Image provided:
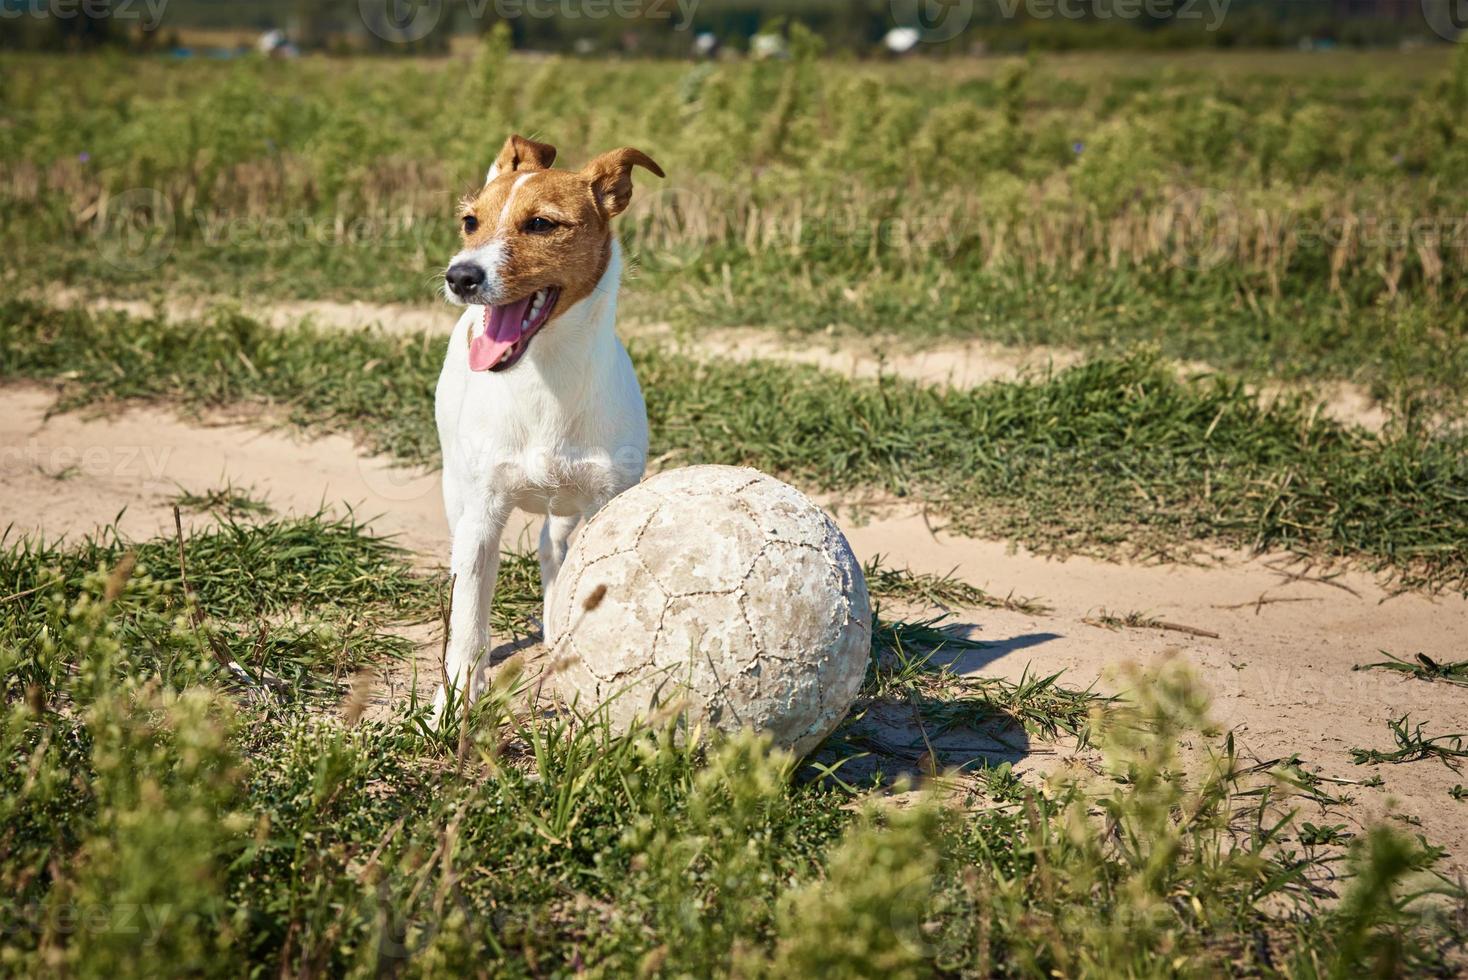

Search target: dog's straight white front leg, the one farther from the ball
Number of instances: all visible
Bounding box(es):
[433,511,505,723]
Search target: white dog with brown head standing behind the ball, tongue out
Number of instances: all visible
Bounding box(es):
[433,135,664,720]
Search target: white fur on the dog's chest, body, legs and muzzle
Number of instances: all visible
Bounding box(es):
[435,233,647,717]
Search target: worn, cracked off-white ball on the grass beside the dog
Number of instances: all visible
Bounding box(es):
[548,467,872,754]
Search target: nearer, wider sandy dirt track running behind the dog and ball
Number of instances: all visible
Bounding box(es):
[0,387,1468,873]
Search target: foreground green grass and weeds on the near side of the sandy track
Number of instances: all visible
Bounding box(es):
[0,516,1468,977]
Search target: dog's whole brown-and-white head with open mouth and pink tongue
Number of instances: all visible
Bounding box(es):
[443,135,662,371]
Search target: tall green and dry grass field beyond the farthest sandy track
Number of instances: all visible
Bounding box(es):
[0,45,1468,404]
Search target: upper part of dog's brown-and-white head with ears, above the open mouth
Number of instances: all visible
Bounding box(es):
[449,135,664,318]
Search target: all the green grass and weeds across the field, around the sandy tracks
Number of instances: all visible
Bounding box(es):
[0,47,1468,977]
